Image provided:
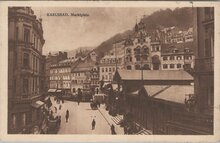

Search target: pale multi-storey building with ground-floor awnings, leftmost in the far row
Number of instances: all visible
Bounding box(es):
[48,58,75,94]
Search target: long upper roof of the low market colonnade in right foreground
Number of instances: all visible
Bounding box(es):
[114,70,193,81]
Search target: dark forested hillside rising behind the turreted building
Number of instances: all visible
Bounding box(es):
[95,8,193,58]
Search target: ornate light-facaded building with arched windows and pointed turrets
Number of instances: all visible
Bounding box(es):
[124,21,152,70]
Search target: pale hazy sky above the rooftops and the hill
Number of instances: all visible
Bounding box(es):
[32,7,166,54]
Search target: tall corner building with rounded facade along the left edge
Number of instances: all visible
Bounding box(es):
[8,7,45,133]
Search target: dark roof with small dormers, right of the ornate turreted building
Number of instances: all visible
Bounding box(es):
[161,42,194,55]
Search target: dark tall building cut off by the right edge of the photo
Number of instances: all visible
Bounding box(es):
[194,7,214,114]
